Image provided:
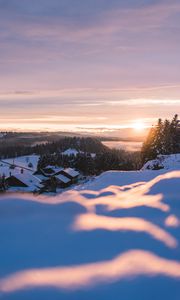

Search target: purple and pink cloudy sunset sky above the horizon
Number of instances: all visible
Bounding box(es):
[0,0,180,136]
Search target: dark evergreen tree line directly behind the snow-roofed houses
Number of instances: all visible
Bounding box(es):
[38,149,140,176]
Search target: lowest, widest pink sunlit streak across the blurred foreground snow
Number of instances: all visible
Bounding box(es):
[0,249,180,293]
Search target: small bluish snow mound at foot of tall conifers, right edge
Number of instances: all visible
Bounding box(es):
[142,153,180,170]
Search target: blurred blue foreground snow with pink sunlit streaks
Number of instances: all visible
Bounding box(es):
[0,170,180,300]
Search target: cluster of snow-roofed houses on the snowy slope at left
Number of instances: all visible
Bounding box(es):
[0,155,82,193]
